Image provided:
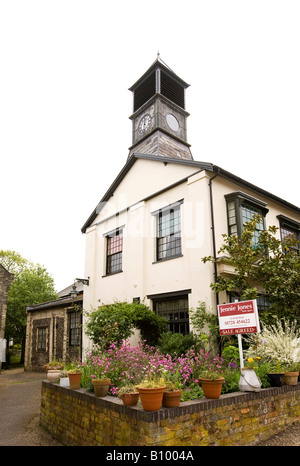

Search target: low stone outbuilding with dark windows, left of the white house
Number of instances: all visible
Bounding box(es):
[25,283,83,372]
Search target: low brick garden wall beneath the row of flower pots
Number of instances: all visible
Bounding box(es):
[40,381,300,446]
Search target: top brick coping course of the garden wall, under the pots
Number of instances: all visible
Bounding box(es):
[42,380,300,422]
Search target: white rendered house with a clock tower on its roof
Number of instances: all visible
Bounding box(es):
[82,58,300,349]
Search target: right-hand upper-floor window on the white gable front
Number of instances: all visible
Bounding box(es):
[156,205,181,261]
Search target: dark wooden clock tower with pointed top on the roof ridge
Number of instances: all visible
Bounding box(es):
[128,54,193,160]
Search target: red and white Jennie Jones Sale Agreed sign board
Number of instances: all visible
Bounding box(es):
[218,299,260,335]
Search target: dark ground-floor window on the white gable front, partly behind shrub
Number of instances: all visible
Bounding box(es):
[153,295,189,335]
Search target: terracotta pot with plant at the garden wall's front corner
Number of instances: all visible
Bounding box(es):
[136,373,166,411]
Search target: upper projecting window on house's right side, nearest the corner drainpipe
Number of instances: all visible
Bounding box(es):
[225,191,268,248]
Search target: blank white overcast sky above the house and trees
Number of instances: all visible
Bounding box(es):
[0,0,300,291]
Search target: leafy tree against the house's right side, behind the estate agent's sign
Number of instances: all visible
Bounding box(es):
[202,215,300,324]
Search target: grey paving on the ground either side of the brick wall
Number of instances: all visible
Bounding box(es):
[0,368,300,446]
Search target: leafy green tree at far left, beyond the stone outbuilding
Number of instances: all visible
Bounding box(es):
[0,250,57,361]
